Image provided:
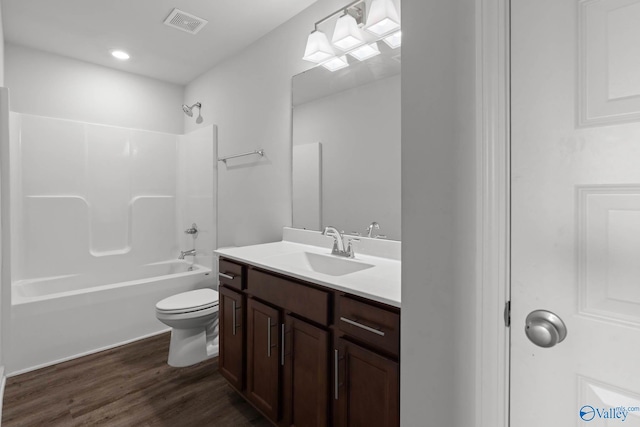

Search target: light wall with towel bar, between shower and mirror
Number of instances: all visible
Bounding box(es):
[184,0,345,247]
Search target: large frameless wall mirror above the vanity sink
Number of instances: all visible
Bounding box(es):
[292,43,401,240]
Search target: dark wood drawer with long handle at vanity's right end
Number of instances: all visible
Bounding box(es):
[336,295,400,356]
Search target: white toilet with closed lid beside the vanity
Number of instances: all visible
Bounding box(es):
[156,288,218,368]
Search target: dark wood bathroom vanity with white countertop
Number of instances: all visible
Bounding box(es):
[216,231,400,427]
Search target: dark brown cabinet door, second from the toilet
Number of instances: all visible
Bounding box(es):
[247,299,281,421]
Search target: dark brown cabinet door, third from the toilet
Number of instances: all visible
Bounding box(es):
[281,315,330,427]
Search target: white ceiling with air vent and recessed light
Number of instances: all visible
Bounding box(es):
[1,0,317,84]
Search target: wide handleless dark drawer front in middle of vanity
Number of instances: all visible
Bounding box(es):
[247,269,330,325]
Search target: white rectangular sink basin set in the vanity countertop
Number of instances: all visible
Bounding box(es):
[269,252,373,276]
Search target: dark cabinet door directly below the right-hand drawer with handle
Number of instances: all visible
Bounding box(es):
[334,338,400,427]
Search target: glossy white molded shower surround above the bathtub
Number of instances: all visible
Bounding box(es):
[10,113,215,288]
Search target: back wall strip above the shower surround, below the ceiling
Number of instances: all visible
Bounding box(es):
[5,43,184,134]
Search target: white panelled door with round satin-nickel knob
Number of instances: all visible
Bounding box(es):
[510,0,640,427]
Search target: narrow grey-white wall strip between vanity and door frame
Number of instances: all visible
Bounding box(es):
[401,0,476,427]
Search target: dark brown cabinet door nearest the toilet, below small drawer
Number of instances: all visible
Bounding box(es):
[218,286,245,390]
